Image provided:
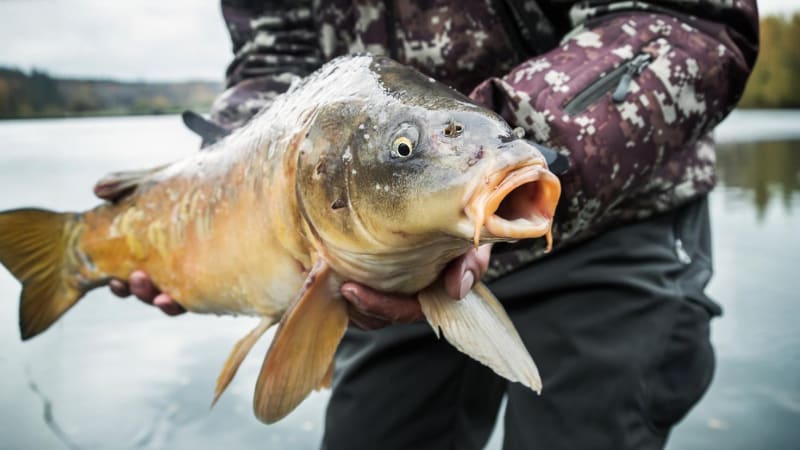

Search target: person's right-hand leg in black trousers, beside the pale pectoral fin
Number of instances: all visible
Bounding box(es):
[490,201,718,450]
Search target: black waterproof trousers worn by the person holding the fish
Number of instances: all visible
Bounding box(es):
[322,198,720,450]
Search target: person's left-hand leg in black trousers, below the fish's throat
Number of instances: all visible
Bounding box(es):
[322,323,506,450]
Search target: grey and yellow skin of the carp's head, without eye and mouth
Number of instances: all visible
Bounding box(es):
[297,58,558,293]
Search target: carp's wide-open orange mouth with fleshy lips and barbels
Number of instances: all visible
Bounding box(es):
[465,163,561,251]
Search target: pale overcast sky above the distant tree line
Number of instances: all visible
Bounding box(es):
[0,0,800,80]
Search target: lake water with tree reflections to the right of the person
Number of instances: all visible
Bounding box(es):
[668,111,800,450]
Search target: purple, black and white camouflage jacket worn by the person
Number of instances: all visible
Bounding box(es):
[206,0,758,278]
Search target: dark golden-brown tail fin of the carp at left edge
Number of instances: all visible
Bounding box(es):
[0,209,86,340]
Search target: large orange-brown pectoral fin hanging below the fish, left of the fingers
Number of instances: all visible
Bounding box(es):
[253,261,348,423]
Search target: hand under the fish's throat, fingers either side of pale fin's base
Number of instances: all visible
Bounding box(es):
[340,244,492,330]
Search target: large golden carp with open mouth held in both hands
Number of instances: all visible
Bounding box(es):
[0,56,560,423]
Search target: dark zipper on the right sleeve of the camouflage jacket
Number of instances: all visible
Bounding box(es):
[564,53,653,116]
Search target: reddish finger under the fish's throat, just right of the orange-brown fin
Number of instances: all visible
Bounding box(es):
[341,283,424,323]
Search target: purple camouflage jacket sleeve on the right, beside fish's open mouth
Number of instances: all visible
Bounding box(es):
[471,0,758,270]
